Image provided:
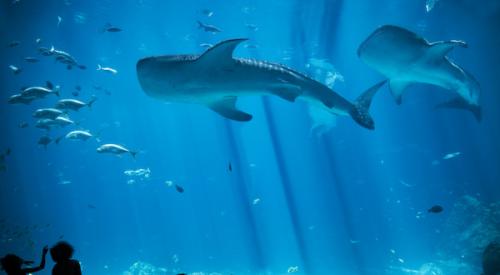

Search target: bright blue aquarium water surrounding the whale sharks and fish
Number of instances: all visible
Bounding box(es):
[0,0,500,275]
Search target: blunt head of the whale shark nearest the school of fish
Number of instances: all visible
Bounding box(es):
[136,55,198,98]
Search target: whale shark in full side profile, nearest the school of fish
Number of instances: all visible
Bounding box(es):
[137,39,385,129]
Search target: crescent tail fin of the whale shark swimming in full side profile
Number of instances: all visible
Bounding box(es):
[350,80,387,130]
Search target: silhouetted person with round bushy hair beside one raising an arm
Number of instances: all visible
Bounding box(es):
[50,242,82,275]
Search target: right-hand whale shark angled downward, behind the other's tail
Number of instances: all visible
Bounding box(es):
[358,25,481,120]
